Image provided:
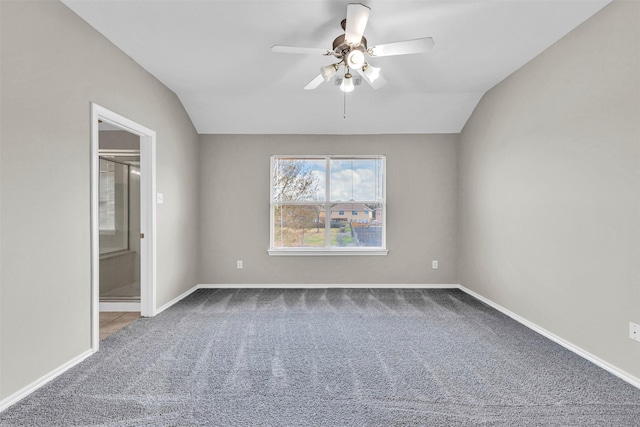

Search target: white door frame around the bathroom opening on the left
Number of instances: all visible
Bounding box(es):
[91,102,156,352]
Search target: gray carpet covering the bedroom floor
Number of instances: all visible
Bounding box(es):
[0,289,640,426]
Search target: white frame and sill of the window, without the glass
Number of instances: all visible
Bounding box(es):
[267,154,389,256]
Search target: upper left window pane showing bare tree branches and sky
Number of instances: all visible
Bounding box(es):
[272,158,326,202]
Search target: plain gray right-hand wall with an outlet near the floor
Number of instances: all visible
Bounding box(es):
[459,1,640,378]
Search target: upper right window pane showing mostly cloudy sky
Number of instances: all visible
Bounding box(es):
[330,157,384,202]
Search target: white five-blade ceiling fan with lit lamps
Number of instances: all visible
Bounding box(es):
[271,3,434,92]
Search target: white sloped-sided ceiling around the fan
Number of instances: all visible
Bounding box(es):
[63,0,610,134]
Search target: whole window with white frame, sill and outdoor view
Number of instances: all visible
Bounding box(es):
[269,156,387,255]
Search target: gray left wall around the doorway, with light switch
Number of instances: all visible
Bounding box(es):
[0,1,198,398]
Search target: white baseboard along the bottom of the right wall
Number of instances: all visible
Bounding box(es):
[459,285,640,388]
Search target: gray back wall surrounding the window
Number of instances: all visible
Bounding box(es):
[199,135,458,285]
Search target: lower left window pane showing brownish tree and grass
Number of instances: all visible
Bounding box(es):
[273,205,326,248]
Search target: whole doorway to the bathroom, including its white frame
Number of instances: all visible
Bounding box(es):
[91,104,156,351]
